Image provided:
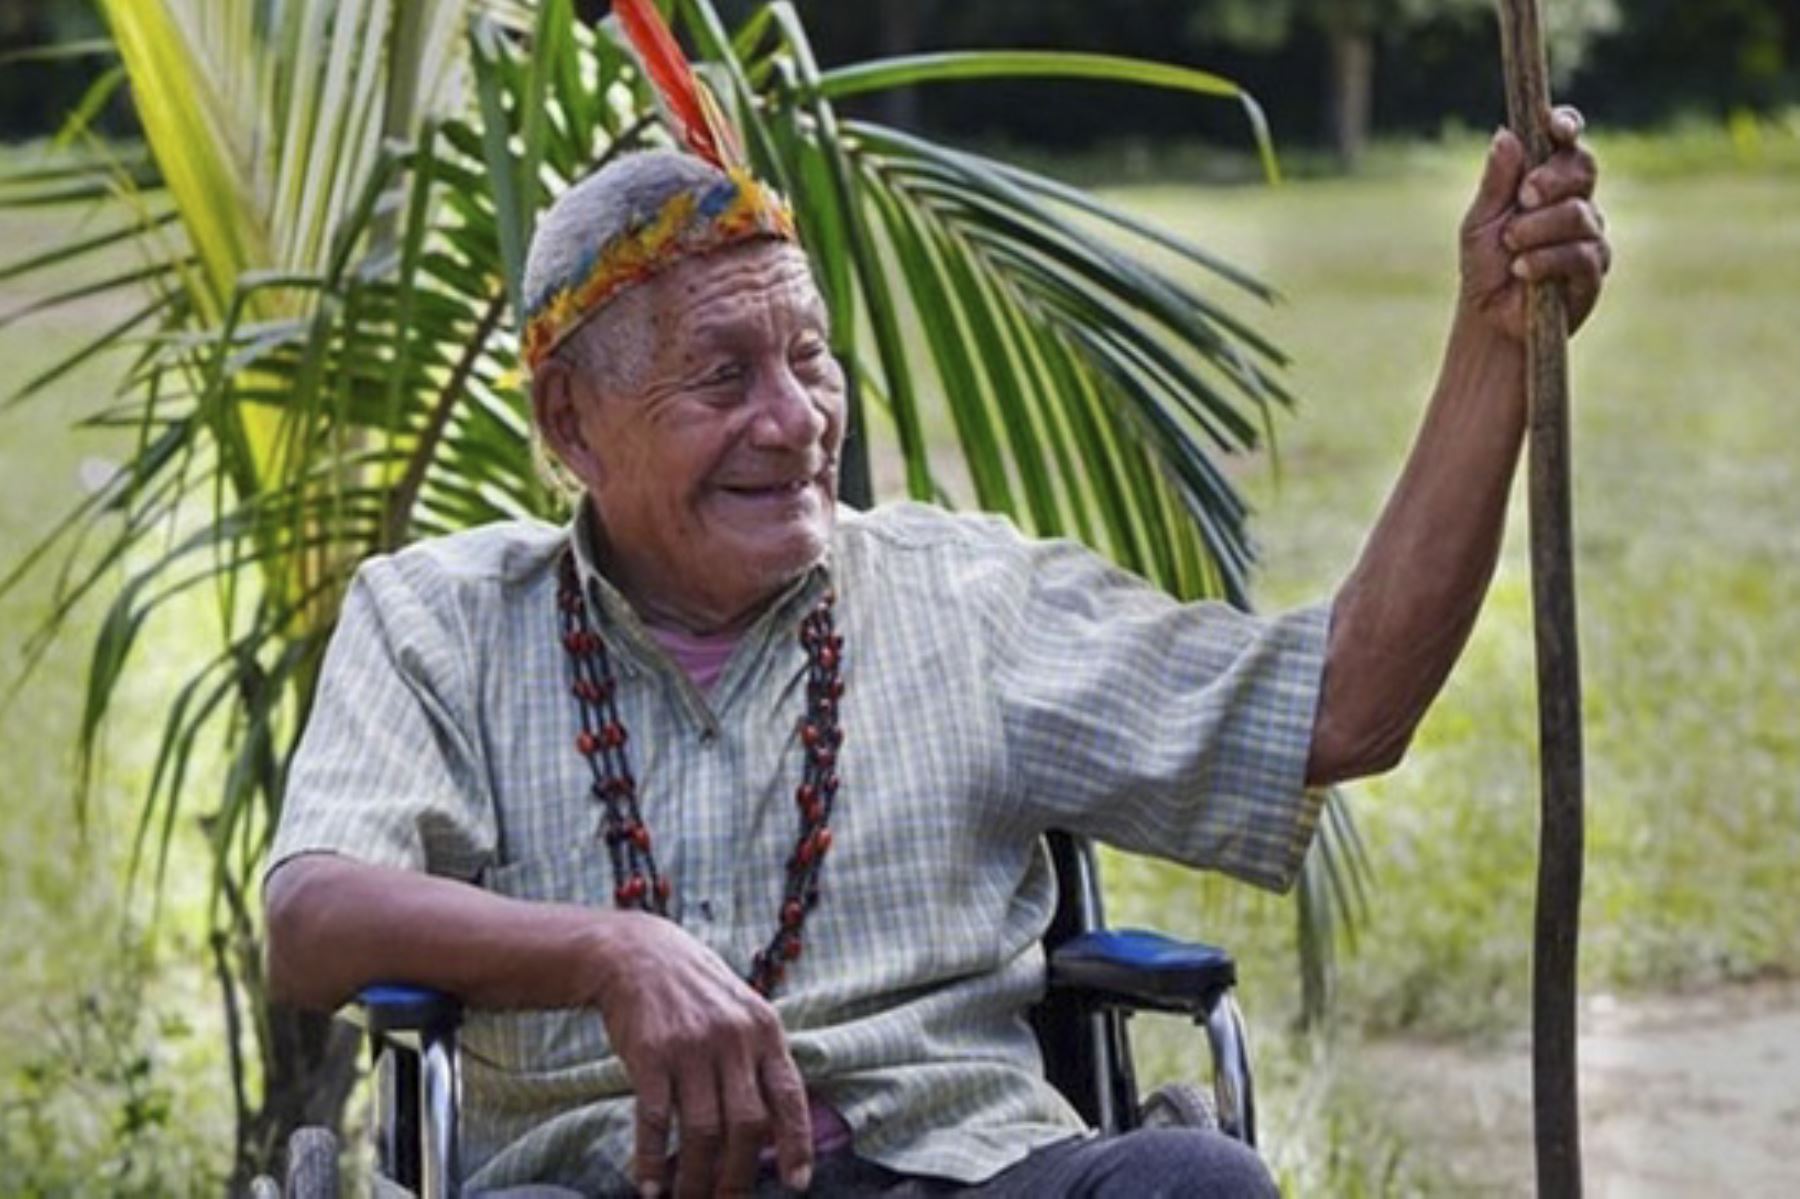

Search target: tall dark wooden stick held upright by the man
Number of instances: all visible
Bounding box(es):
[1499,0,1584,1199]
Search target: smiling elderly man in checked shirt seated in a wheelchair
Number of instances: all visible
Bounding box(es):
[268,110,1607,1195]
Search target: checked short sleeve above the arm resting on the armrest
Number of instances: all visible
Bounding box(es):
[268,558,497,879]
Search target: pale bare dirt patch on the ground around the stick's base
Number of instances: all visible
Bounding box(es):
[1364,983,1800,1199]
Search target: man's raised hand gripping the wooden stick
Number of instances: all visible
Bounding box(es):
[1462,108,1613,342]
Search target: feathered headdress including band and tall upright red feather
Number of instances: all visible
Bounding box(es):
[524,0,796,369]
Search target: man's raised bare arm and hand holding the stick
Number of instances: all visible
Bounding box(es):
[1307,108,1609,785]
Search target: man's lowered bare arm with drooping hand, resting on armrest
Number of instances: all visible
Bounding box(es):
[266,853,812,1194]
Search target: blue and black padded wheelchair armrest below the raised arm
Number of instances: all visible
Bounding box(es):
[1049,929,1237,1015]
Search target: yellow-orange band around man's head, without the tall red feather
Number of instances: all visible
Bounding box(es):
[524,167,796,371]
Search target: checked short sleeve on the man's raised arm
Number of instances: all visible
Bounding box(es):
[997,542,1330,889]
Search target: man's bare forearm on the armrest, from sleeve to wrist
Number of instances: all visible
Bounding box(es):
[266,853,619,1010]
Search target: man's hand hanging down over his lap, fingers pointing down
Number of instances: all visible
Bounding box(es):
[596,913,812,1195]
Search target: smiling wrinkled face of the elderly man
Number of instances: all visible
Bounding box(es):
[558,241,844,627]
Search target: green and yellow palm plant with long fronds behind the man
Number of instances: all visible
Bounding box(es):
[0,0,1359,1168]
